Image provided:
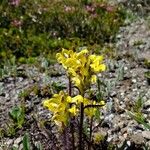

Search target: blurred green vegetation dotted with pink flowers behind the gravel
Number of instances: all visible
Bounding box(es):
[0,0,125,62]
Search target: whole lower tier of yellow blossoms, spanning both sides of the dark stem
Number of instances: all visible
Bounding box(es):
[43,91,105,127]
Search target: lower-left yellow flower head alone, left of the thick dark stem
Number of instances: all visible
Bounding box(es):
[43,91,78,127]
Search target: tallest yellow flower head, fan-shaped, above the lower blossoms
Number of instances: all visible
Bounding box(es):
[56,49,106,93]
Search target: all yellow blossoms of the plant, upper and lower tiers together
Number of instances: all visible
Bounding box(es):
[43,49,106,127]
